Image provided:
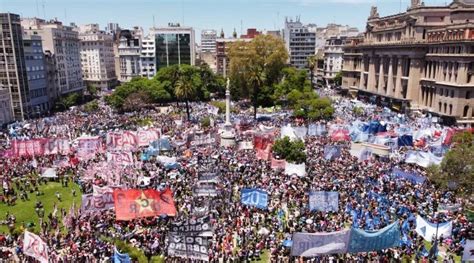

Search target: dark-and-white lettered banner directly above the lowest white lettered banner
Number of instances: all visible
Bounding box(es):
[170,216,213,237]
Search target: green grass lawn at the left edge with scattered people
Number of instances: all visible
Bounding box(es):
[0,182,81,233]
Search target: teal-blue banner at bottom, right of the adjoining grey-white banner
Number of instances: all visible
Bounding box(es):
[348,221,401,253]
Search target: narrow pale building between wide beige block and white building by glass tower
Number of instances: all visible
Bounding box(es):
[117,30,143,82]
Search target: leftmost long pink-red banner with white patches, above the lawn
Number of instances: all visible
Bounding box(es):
[12,138,71,157]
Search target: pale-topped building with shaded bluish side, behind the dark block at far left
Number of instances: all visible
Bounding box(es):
[21,18,85,99]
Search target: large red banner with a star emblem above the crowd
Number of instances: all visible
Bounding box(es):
[114,188,176,220]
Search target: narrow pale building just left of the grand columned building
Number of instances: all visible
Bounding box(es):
[323,36,346,82]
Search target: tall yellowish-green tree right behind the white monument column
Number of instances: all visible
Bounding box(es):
[228,35,288,118]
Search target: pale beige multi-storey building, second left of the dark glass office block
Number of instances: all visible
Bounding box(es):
[79,24,117,90]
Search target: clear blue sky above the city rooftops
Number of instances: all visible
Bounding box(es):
[0,0,451,41]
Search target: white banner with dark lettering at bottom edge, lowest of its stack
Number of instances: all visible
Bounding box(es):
[168,234,209,261]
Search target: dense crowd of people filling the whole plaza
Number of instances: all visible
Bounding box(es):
[0,94,473,262]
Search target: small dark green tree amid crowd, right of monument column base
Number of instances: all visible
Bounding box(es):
[272,136,306,164]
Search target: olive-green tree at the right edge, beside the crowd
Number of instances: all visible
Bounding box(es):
[428,132,474,197]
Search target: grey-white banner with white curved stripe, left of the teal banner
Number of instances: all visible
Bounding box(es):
[291,230,350,257]
